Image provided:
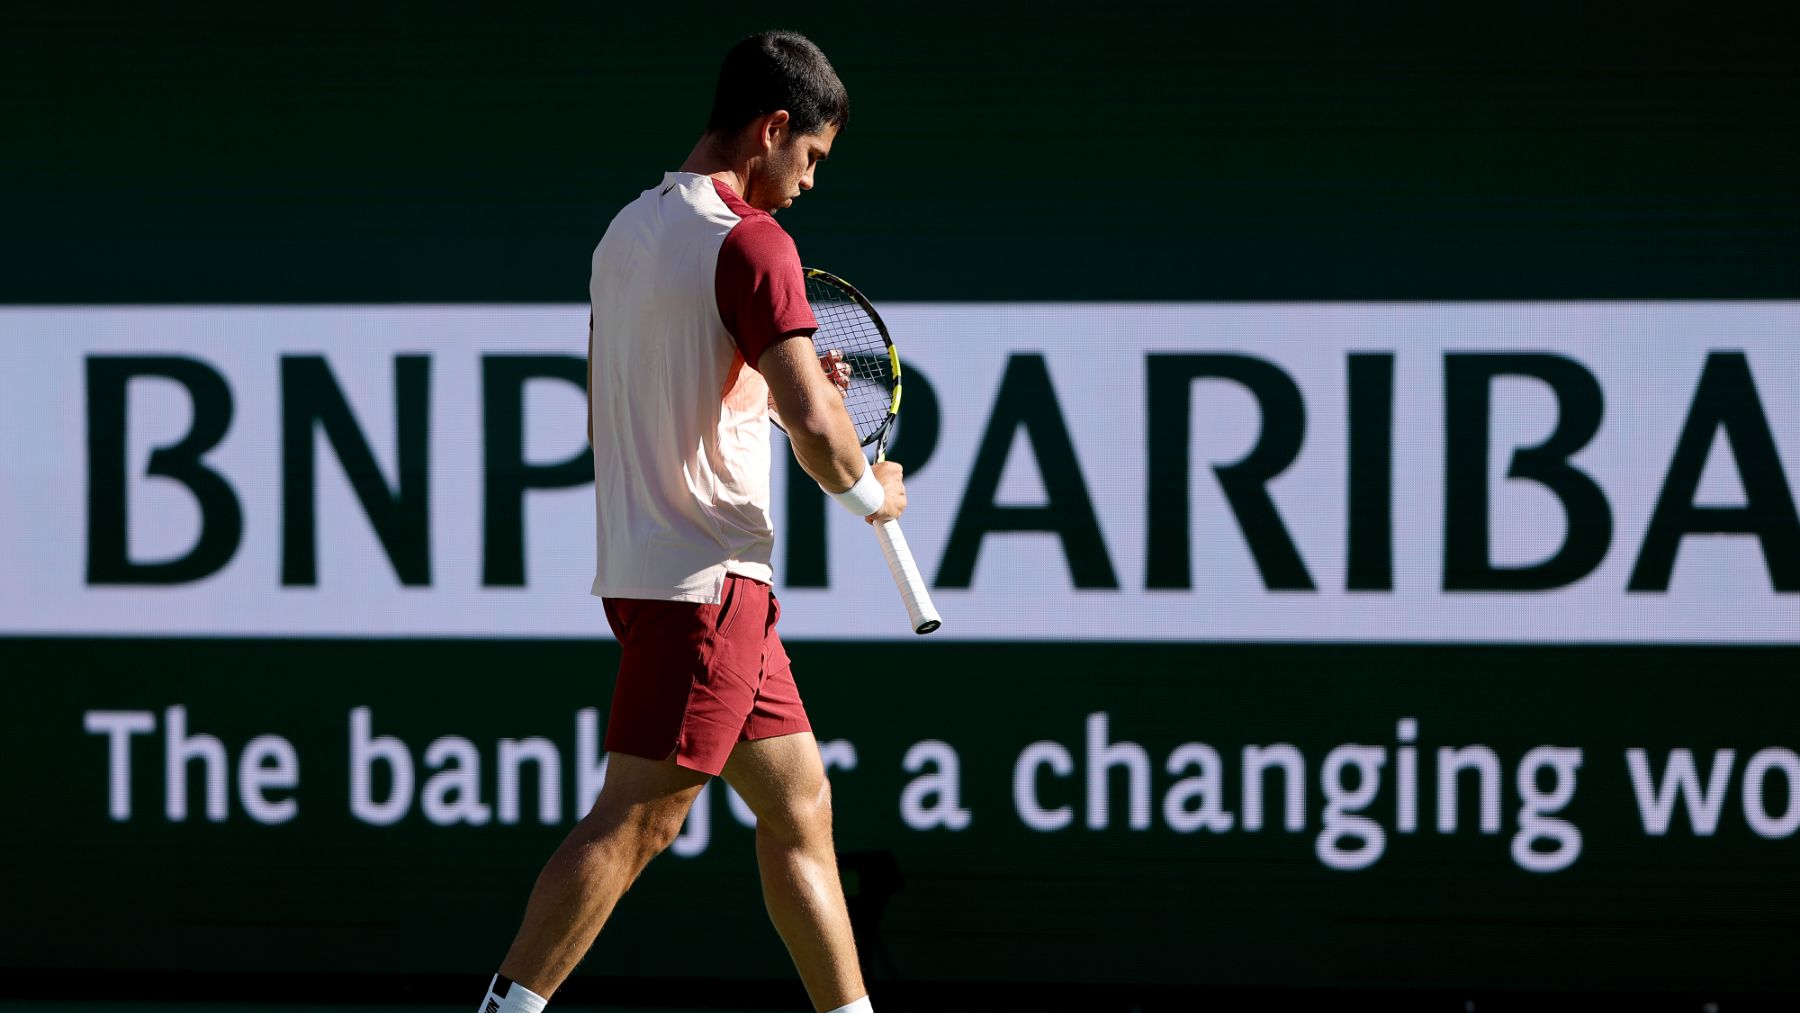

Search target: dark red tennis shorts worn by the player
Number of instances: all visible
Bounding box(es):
[603,574,812,775]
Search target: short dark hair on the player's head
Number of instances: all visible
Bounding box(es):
[706,32,850,135]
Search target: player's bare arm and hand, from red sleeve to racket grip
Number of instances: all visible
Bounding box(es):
[756,335,905,524]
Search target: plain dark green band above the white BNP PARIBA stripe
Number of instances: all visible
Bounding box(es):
[0,0,1800,302]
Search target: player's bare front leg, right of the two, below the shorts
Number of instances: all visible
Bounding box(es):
[725,732,866,1011]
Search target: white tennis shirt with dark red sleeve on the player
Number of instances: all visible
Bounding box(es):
[587,173,817,605]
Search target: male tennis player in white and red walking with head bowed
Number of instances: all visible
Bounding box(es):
[481,32,905,1013]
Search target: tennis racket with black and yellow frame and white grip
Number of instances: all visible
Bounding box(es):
[806,268,943,633]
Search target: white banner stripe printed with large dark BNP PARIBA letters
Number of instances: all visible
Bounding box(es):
[0,302,1800,644]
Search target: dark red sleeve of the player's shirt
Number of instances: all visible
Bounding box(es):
[713,216,819,369]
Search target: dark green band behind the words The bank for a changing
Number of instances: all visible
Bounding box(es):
[10,641,1800,991]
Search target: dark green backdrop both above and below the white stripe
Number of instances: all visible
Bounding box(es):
[0,2,1800,995]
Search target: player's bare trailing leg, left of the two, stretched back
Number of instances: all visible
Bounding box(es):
[500,752,707,999]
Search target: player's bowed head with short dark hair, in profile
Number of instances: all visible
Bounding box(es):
[706,32,850,211]
